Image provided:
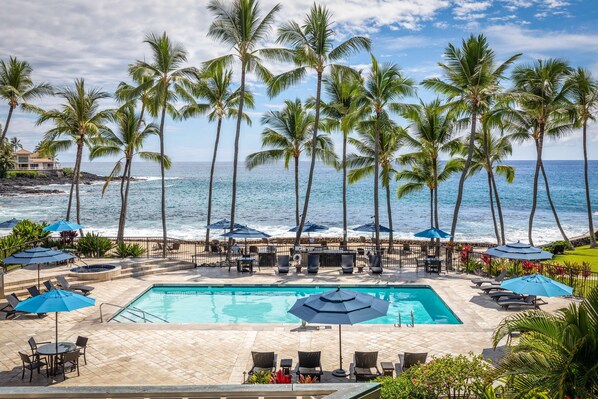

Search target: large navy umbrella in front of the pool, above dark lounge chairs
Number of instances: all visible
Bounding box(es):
[288,288,389,377]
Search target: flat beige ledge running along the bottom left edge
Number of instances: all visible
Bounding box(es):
[0,383,380,399]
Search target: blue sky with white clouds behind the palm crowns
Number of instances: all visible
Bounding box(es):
[0,0,598,162]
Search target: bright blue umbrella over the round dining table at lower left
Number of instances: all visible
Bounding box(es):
[15,290,96,352]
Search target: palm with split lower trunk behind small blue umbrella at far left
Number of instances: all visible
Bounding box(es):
[36,78,114,227]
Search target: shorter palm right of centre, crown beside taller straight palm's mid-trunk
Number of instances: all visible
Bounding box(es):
[347,113,405,253]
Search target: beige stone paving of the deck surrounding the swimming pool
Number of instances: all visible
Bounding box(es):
[0,267,569,386]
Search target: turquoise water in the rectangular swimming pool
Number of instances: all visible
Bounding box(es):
[112,285,461,324]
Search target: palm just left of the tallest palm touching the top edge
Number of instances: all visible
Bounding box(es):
[179,65,254,251]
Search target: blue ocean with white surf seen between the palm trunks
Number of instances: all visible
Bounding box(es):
[0,161,598,243]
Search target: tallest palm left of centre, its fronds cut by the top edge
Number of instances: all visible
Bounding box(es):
[205,0,284,253]
